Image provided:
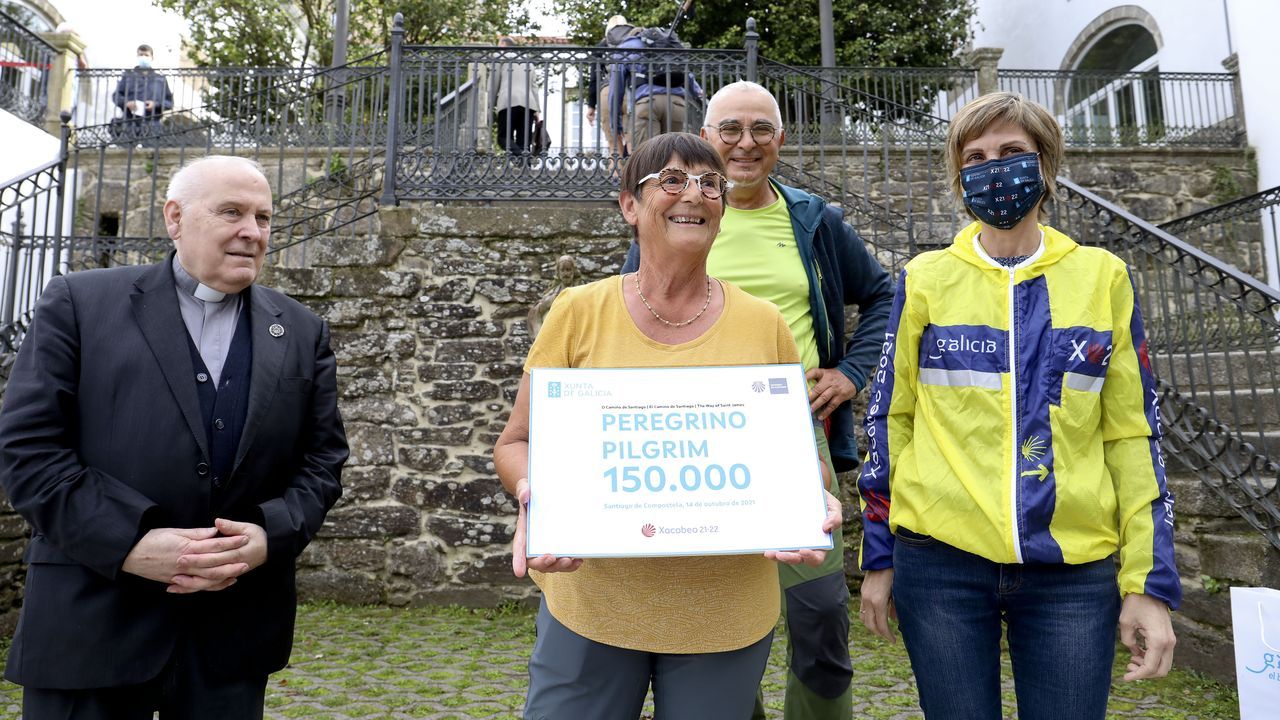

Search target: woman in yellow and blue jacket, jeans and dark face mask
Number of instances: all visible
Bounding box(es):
[858,92,1181,720]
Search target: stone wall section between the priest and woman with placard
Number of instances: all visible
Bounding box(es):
[281,205,640,605]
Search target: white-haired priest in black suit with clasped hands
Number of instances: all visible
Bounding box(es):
[0,156,348,720]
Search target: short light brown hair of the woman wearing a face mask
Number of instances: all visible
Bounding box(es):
[946,92,1064,221]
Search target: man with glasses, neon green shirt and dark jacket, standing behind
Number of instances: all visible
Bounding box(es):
[622,82,893,720]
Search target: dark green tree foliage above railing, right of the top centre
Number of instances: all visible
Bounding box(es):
[556,0,974,68]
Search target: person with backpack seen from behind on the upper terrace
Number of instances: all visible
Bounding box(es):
[609,23,703,147]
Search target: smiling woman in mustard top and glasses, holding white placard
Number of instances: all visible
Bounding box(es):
[494,133,840,720]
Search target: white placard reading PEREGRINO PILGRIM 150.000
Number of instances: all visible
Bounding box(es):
[526,365,831,557]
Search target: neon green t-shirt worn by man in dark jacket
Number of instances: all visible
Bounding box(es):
[707,196,818,370]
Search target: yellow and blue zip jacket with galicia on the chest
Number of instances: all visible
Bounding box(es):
[858,223,1181,607]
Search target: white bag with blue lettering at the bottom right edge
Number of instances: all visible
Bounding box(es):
[1231,588,1280,720]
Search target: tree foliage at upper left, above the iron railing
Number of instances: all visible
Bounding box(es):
[152,0,536,67]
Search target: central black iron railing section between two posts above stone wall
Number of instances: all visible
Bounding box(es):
[392,37,745,200]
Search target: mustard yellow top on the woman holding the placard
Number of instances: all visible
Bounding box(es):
[525,277,800,653]
